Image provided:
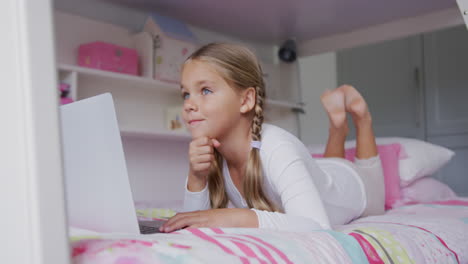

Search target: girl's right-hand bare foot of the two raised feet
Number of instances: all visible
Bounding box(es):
[337,85,372,126]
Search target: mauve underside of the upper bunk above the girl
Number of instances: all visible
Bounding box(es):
[108,0,456,42]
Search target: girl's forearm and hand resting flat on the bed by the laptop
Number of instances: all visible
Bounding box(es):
[159,208,258,233]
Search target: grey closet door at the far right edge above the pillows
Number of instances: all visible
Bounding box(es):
[424,26,468,136]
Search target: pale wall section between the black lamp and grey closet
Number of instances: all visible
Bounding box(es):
[299,52,337,145]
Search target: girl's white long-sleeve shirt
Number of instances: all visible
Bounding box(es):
[184,124,368,231]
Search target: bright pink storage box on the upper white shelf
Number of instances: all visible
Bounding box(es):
[78,41,139,75]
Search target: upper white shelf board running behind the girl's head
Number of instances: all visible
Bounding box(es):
[58,64,303,111]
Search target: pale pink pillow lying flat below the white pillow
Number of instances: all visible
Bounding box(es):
[394,176,457,207]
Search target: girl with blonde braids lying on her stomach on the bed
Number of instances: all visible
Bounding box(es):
[161,43,385,232]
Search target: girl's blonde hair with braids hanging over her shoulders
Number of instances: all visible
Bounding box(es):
[186,43,277,211]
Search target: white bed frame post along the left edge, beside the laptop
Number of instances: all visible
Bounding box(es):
[0,0,70,264]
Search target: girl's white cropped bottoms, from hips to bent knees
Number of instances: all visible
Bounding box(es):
[316,156,385,226]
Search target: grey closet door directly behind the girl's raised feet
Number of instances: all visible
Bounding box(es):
[337,36,424,139]
